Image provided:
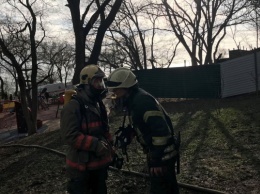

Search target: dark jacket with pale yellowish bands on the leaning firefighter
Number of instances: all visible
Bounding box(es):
[126,88,177,167]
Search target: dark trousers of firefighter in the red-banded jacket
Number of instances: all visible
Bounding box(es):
[67,168,107,194]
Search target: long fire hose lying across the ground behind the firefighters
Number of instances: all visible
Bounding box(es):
[0,144,225,194]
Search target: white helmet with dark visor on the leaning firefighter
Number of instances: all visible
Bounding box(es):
[107,67,138,89]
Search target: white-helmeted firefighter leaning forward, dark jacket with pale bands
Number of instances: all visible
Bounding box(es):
[106,68,179,194]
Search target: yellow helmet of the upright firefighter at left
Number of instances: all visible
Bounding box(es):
[80,64,105,85]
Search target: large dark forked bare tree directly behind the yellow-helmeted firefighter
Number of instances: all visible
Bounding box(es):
[66,0,123,84]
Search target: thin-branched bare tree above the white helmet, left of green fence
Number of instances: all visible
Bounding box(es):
[101,0,178,70]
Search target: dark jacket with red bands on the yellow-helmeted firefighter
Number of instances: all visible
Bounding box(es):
[60,89,112,178]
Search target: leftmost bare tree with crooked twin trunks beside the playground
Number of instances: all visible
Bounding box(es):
[0,0,53,135]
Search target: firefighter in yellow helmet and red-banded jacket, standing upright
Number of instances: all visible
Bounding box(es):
[60,65,113,194]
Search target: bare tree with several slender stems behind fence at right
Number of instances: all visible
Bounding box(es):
[163,0,252,66]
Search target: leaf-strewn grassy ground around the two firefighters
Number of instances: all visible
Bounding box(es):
[0,96,260,194]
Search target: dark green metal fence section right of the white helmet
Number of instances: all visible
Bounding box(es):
[134,64,221,98]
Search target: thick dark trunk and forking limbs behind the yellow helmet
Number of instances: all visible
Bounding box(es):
[66,0,123,84]
